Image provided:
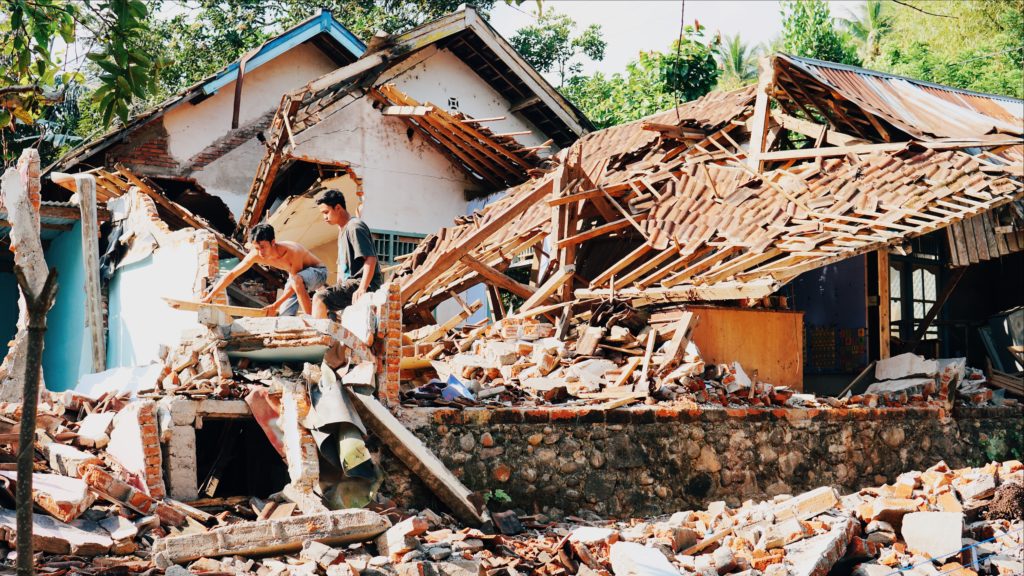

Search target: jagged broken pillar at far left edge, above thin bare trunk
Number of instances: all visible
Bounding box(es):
[0,149,49,402]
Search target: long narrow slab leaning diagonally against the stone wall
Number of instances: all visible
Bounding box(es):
[346,388,487,526]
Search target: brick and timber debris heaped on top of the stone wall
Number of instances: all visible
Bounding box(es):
[402,302,1018,408]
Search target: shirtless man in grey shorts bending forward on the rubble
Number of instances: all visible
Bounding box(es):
[201,224,327,316]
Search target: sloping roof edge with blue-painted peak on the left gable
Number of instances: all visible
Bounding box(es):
[49,9,367,173]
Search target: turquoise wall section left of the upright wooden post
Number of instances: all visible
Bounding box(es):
[43,222,92,392]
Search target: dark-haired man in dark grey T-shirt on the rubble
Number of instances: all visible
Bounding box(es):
[313,190,383,318]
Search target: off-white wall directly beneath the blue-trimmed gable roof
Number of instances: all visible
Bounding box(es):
[164,43,337,161]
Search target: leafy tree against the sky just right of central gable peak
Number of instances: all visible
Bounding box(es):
[510,9,607,86]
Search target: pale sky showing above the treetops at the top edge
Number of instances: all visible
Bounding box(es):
[490,0,862,80]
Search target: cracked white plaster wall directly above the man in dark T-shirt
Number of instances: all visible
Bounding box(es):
[293,97,478,234]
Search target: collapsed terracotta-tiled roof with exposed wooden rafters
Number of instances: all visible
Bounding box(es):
[391,56,1024,318]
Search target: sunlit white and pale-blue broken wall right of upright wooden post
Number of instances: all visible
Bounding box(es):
[106,241,200,368]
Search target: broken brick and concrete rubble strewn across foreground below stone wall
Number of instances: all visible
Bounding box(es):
[0,453,1024,576]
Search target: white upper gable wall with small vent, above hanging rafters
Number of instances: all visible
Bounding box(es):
[381,46,558,156]
